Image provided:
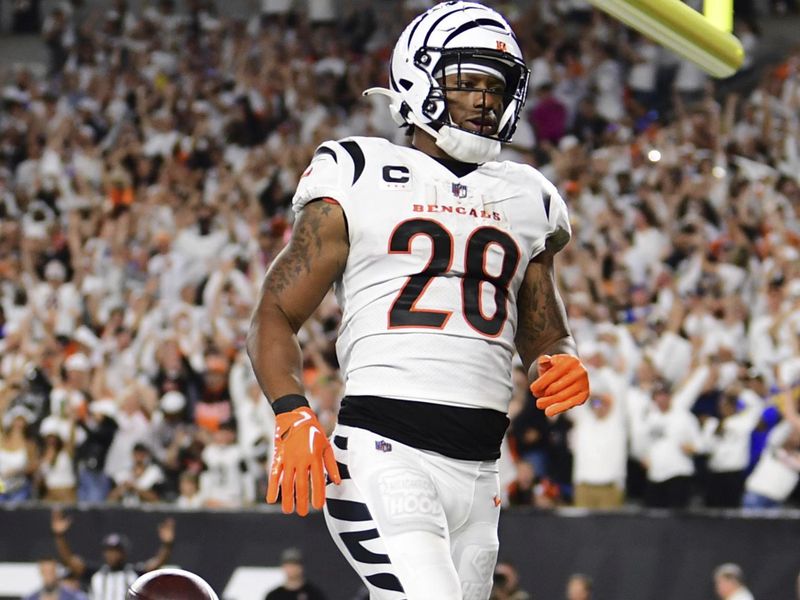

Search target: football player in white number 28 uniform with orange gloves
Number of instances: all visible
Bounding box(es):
[248,1,589,600]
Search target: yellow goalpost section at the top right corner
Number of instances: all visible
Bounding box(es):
[589,0,744,78]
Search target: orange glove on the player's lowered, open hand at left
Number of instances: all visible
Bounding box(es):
[267,406,342,517]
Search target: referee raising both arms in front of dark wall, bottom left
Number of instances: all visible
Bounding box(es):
[50,510,175,600]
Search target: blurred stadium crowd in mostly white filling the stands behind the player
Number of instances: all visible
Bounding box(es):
[0,0,800,508]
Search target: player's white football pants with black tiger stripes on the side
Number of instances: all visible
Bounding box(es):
[325,425,500,600]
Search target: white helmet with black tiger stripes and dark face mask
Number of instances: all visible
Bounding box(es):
[364,0,530,163]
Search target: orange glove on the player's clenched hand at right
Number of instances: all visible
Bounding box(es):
[531,354,589,417]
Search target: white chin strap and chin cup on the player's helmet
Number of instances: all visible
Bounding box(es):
[364,87,501,163]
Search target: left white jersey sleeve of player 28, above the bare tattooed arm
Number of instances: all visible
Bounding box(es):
[292,142,350,212]
